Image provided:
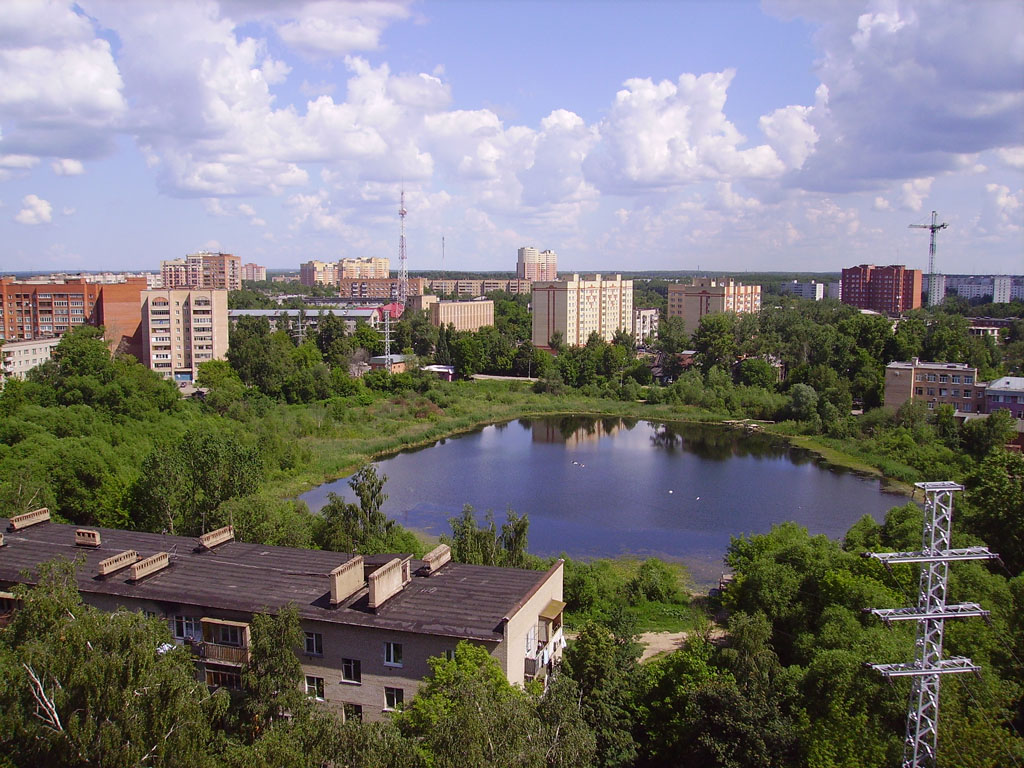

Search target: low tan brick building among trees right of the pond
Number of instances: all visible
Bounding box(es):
[885,357,985,413]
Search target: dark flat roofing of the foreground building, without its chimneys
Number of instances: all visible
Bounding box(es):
[0,518,548,641]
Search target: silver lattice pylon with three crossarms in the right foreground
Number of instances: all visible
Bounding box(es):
[864,482,998,768]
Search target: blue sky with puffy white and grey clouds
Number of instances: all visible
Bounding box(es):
[0,0,1024,274]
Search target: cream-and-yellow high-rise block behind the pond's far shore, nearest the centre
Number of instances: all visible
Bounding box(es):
[532,274,633,349]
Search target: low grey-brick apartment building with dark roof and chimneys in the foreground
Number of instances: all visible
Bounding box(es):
[0,518,565,720]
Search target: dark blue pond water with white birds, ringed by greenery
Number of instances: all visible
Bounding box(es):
[301,417,906,584]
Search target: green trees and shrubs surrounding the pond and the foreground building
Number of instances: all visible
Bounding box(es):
[0,296,1024,768]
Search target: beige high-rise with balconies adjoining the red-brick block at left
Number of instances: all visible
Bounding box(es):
[141,289,227,381]
